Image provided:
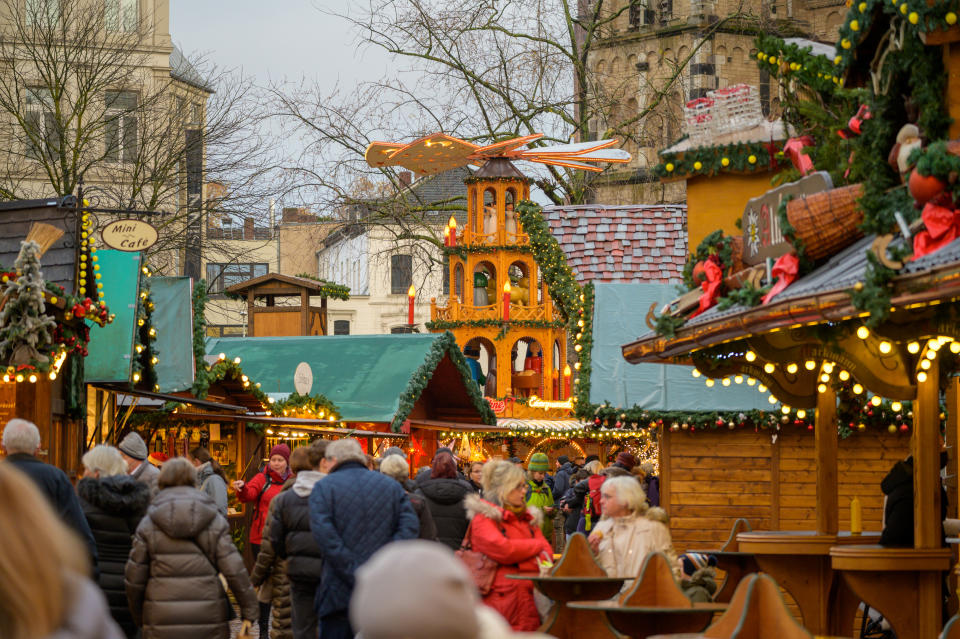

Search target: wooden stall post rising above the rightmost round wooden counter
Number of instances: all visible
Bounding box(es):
[910,358,943,548]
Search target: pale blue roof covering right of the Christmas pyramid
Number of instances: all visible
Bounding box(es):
[590,282,770,411]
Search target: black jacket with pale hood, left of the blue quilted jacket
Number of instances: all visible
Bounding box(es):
[270,470,326,583]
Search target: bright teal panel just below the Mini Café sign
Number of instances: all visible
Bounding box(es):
[83,250,140,382]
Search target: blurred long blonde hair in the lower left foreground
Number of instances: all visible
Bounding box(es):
[0,463,90,639]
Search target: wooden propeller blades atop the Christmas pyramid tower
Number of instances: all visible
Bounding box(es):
[364,133,630,175]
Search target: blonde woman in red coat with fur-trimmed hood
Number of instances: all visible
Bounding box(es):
[464,461,553,631]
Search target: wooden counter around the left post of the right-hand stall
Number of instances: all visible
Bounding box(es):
[737,530,880,635]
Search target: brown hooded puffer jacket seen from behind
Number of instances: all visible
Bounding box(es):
[125,486,259,639]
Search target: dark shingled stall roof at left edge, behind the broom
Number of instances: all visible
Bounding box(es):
[0,195,77,292]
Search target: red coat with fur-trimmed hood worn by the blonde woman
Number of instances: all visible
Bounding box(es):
[465,494,553,631]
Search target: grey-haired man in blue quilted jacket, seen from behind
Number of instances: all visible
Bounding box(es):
[309,439,420,639]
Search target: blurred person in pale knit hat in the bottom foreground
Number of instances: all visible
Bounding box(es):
[350,540,547,639]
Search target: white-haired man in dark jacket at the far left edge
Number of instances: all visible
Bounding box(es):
[3,418,97,572]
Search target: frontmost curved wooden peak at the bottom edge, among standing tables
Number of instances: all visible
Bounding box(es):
[703,573,813,639]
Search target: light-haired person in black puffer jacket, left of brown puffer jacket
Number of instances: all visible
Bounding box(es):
[77,445,150,638]
